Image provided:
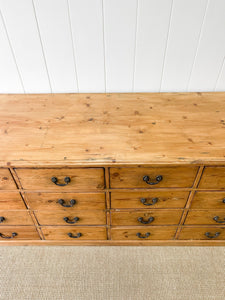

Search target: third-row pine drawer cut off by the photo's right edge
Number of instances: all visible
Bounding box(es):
[185,210,225,225]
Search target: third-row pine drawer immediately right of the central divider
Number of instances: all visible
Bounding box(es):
[111,209,183,226]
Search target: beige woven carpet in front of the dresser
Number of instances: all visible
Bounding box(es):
[0,247,225,300]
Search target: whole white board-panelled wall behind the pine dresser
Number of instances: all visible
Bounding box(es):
[0,0,225,93]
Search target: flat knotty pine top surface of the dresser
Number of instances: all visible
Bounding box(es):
[0,92,225,166]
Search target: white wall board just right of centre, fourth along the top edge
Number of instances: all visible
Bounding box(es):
[103,0,137,92]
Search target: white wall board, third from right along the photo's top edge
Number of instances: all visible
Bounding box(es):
[134,0,172,92]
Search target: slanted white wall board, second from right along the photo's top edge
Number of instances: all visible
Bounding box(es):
[161,0,208,92]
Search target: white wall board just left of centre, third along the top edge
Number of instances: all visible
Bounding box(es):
[68,0,105,93]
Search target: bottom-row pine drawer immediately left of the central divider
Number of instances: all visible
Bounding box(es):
[41,226,107,241]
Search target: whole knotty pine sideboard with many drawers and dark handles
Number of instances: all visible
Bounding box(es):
[0,93,225,246]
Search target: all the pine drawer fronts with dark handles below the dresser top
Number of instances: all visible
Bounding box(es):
[0,166,225,241]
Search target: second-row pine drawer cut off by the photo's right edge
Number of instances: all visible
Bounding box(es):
[191,192,225,209]
